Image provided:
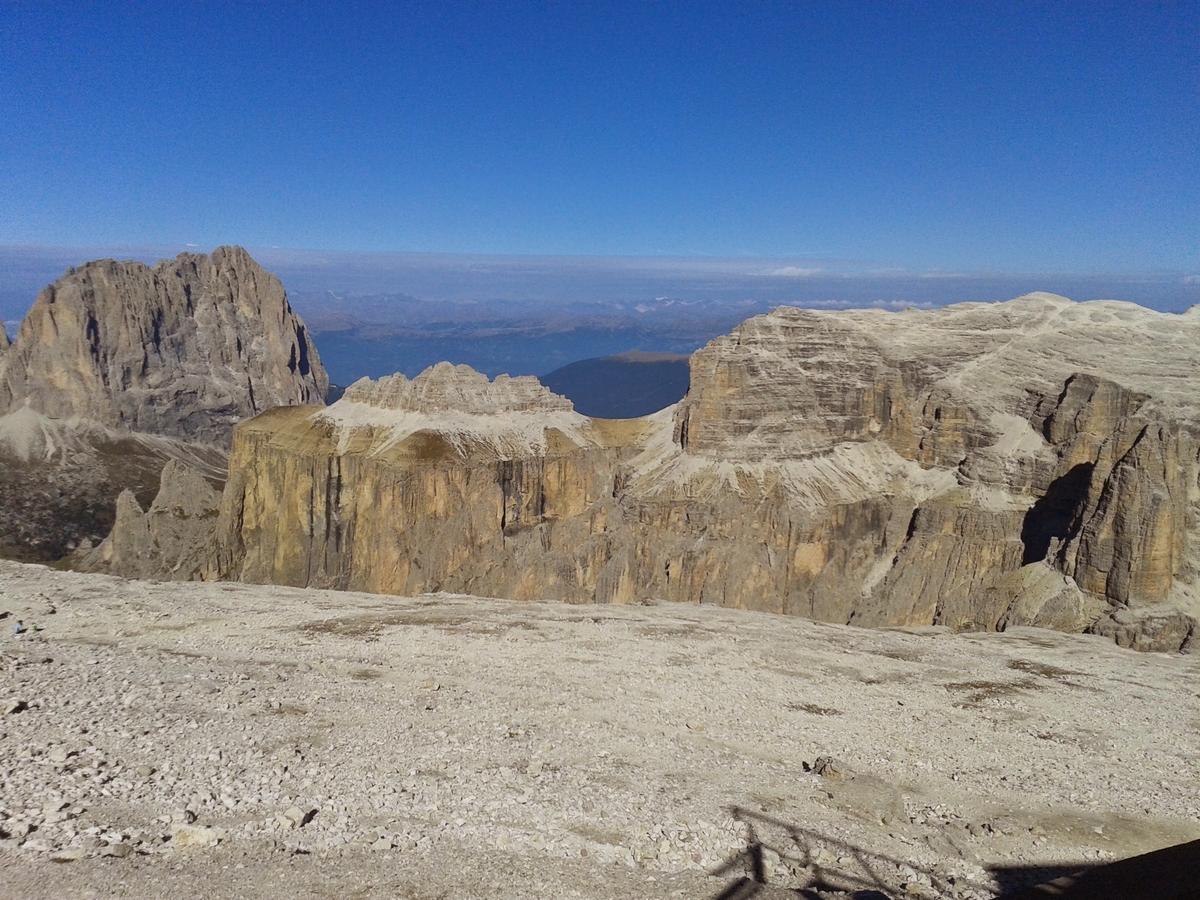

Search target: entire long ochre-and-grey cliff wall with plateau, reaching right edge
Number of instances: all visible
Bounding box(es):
[100,295,1200,650]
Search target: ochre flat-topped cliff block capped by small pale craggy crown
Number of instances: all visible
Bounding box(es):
[205,364,633,600]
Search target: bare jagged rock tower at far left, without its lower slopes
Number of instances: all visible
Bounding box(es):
[0,247,329,444]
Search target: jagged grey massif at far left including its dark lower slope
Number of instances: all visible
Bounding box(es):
[0,247,329,560]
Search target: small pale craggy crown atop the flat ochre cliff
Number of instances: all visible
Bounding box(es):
[340,362,574,415]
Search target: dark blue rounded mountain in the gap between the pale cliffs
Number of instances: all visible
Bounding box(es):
[539,350,688,419]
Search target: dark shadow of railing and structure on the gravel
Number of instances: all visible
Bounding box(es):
[710,806,1200,900]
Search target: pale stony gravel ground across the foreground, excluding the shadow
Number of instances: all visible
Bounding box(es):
[0,563,1200,898]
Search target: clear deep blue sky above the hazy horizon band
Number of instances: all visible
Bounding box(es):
[0,0,1200,274]
